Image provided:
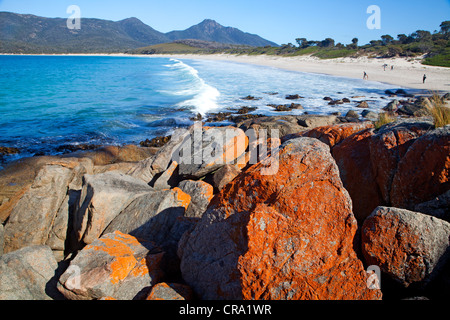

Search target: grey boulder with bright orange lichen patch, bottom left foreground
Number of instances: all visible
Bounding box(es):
[58,231,164,300]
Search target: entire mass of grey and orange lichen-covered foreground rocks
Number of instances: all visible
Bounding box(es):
[0,93,450,300]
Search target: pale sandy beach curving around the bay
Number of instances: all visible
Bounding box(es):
[1,53,450,93]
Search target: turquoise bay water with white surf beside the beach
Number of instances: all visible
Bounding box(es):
[0,55,398,165]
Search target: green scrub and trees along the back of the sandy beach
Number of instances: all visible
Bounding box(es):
[131,21,450,67]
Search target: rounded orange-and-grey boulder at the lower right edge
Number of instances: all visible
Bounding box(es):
[362,207,450,287]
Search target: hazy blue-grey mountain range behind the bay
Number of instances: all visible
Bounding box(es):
[0,12,277,53]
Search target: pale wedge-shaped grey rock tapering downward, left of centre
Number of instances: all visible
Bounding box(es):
[74,172,153,244]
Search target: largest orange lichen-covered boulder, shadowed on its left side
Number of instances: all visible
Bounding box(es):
[178,138,381,300]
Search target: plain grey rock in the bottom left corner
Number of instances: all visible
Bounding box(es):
[0,246,58,300]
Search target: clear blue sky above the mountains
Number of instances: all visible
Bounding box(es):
[0,0,450,44]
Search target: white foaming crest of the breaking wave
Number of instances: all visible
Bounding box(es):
[166,59,220,115]
